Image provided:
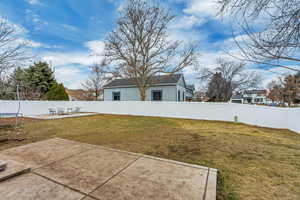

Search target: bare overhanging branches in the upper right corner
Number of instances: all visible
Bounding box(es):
[219,0,300,71]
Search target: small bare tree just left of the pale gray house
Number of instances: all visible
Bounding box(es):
[82,65,107,100]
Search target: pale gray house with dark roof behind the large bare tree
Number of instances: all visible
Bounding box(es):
[104,74,193,101]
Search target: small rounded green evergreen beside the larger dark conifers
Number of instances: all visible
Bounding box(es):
[47,83,69,101]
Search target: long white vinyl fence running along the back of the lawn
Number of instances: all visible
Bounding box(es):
[0,101,300,133]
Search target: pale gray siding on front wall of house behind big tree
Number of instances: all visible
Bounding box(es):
[104,85,177,101]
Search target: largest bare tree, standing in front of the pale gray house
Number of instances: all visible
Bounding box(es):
[103,0,196,101]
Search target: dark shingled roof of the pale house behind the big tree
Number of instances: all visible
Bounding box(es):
[104,74,183,88]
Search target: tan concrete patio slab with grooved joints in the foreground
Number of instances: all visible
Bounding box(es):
[0,138,217,200]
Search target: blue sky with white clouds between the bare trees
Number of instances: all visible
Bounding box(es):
[0,0,292,89]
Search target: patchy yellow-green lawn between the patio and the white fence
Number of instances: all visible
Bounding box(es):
[0,115,300,200]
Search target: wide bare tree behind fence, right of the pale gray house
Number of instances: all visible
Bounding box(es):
[199,59,261,102]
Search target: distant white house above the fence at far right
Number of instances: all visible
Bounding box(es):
[230,90,271,104]
